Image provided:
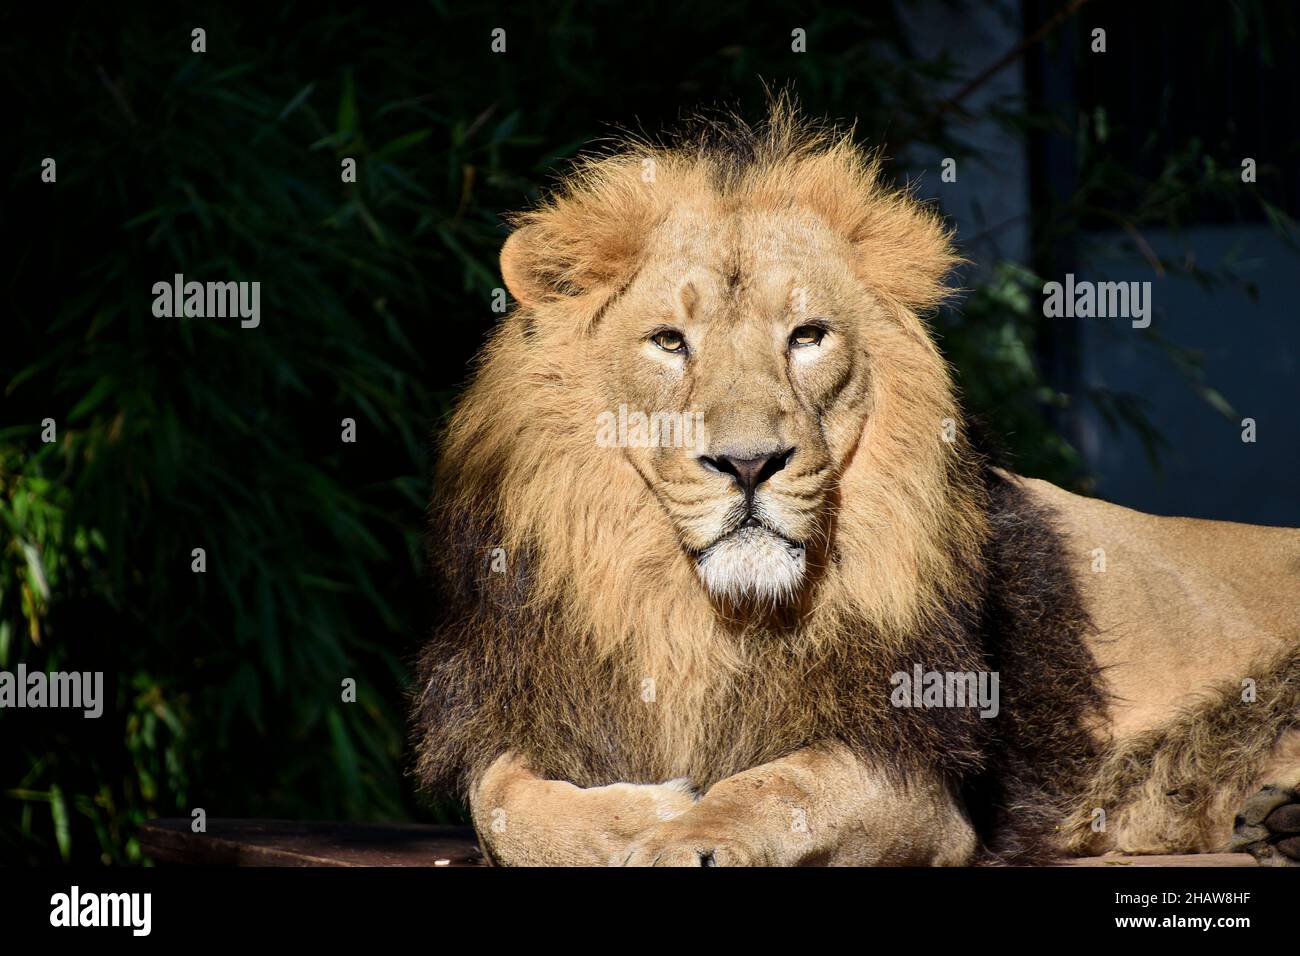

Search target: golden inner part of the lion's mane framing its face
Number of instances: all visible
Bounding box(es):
[416,93,987,783]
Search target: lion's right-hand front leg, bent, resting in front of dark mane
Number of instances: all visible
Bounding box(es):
[620,747,976,866]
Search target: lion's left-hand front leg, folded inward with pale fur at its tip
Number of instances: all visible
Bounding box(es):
[469,753,696,866]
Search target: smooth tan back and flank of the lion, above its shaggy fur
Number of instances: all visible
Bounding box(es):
[1022,479,1300,740]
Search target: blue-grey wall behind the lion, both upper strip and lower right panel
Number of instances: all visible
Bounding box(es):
[900,0,1300,527]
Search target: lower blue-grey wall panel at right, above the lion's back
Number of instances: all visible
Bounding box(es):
[1076,225,1300,527]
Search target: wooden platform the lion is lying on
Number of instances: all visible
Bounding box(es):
[140,818,1256,868]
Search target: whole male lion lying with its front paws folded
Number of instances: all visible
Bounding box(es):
[415,100,1300,866]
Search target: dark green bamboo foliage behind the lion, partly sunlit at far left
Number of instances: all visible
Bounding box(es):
[0,3,1294,862]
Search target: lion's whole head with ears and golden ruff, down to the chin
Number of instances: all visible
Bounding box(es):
[480,107,983,632]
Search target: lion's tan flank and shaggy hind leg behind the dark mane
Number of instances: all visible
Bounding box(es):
[1024,480,1300,853]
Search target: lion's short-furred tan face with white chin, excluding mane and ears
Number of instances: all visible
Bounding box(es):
[593,211,871,600]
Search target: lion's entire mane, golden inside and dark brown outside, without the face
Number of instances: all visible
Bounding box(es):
[415,100,1101,858]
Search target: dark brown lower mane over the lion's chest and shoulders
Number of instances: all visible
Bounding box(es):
[415,452,1105,862]
